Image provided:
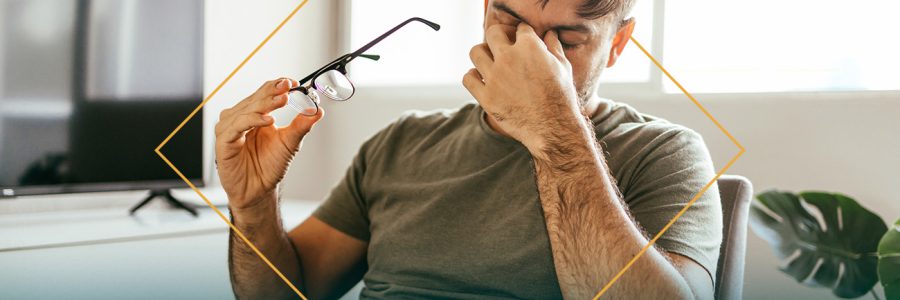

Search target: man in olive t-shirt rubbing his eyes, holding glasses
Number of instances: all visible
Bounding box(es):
[216,0,722,299]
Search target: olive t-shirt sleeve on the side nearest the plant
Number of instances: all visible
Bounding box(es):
[623,128,722,279]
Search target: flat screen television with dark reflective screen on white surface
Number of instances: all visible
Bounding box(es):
[0,0,204,197]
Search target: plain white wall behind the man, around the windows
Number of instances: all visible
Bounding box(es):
[206,0,900,299]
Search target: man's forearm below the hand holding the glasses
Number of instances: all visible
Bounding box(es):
[228,191,301,299]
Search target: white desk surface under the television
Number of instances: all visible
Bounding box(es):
[0,199,318,299]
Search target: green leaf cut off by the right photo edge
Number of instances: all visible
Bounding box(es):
[878,219,900,300]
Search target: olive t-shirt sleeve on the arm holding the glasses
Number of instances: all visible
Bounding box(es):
[313,139,370,241]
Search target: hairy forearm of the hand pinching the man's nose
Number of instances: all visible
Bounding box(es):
[532,118,693,299]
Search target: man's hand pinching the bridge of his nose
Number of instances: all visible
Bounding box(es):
[463,23,583,152]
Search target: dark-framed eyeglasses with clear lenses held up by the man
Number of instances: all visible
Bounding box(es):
[288,18,441,116]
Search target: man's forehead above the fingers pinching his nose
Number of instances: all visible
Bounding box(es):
[491,0,609,32]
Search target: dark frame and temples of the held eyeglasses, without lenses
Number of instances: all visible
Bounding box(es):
[290,17,441,111]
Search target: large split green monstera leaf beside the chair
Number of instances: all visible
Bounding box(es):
[750,191,887,298]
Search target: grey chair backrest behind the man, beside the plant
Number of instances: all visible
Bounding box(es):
[716,175,753,300]
